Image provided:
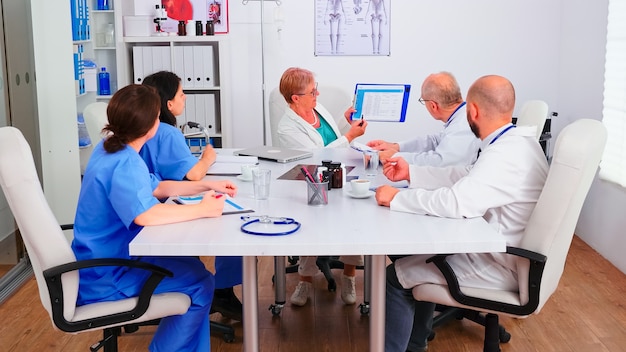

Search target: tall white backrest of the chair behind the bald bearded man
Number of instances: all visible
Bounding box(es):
[518,119,607,312]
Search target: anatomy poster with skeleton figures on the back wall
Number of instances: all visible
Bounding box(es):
[315,0,391,56]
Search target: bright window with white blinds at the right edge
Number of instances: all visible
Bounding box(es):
[600,0,626,187]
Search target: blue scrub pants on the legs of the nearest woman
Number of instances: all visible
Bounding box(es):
[121,257,215,352]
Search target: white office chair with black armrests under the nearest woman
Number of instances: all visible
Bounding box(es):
[0,127,234,352]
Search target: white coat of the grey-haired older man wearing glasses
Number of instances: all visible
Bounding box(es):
[394,104,480,167]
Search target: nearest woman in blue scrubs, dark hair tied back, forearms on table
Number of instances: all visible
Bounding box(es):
[72,85,236,351]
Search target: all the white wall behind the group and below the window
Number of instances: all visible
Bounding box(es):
[229,0,626,273]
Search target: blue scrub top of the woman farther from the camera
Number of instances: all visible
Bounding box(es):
[139,122,198,181]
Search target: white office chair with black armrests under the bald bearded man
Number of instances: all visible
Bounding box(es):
[413,119,607,352]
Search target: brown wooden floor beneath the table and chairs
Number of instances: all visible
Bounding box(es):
[0,237,626,352]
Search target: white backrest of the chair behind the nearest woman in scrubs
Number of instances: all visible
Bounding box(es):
[0,127,78,319]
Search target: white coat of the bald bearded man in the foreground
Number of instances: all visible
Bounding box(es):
[390,125,548,288]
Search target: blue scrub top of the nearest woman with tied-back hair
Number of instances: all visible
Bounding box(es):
[72,141,159,305]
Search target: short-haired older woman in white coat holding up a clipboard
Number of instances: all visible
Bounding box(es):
[277,67,367,306]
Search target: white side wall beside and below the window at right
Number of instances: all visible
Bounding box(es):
[556,0,626,273]
